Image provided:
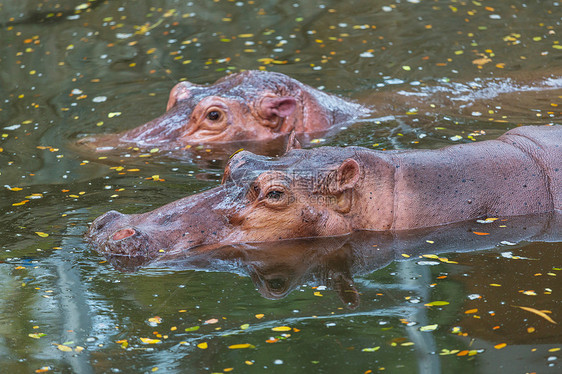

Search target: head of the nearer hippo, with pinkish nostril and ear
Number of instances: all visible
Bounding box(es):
[86,147,392,258]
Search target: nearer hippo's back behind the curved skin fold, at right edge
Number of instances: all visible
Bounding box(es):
[498,125,562,210]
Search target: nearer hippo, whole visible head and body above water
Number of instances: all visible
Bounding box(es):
[87,126,562,257]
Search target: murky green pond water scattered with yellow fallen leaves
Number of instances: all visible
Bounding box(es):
[0,0,562,373]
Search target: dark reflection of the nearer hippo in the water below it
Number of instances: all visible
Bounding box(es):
[100,212,562,308]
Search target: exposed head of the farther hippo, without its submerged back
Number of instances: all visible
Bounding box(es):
[79,71,367,151]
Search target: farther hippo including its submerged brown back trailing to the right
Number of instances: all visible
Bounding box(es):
[76,70,562,160]
